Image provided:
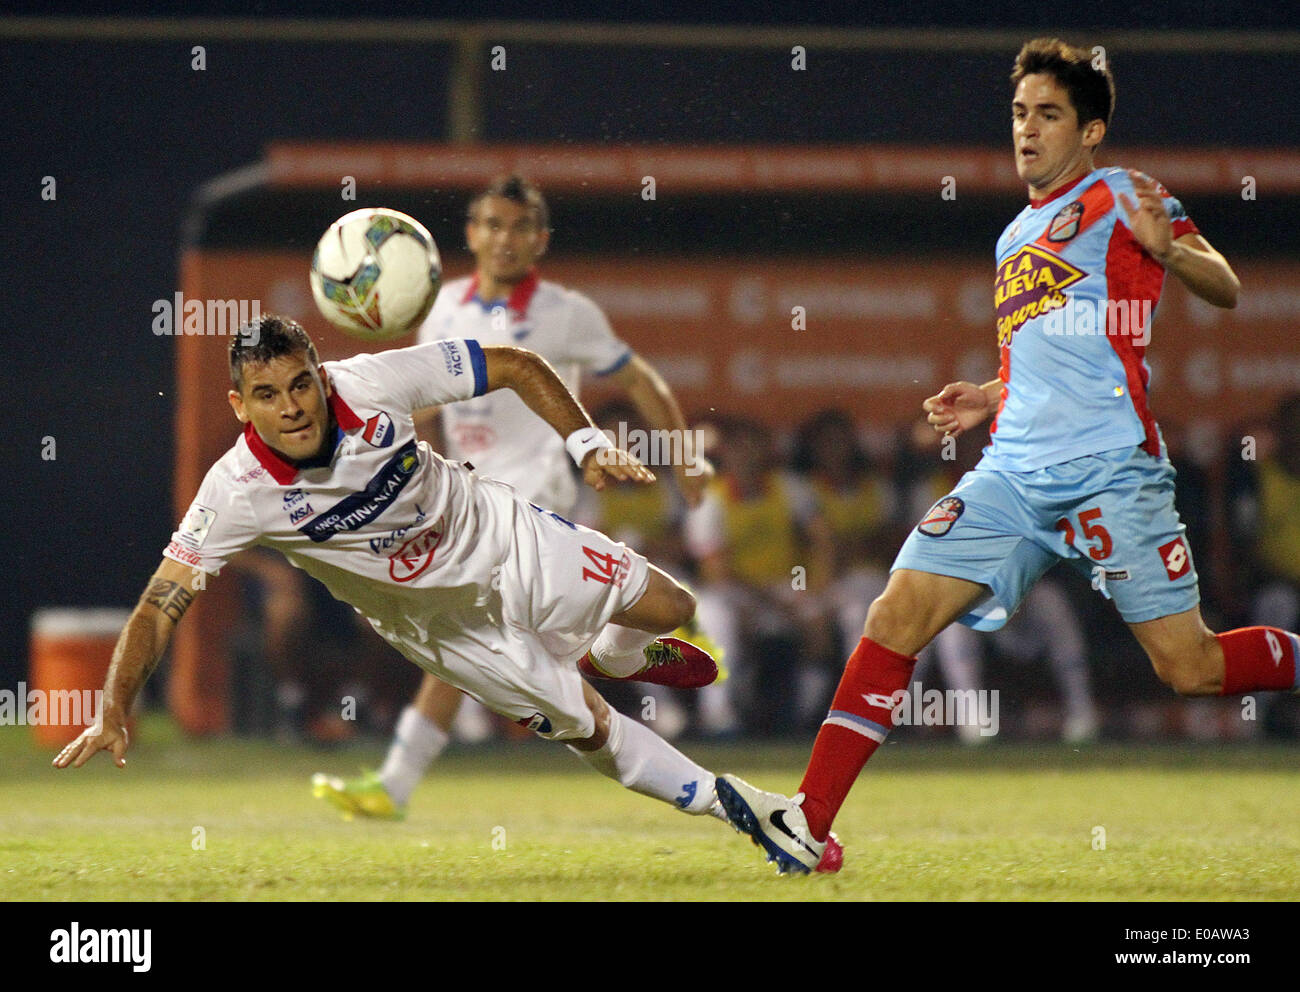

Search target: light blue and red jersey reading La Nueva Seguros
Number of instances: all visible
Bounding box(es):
[980,168,1196,471]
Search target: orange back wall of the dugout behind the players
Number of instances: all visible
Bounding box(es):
[169,250,1300,733]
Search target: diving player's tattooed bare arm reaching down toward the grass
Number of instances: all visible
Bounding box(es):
[53,558,199,768]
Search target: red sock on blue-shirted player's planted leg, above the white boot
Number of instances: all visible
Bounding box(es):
[800,637,917,840]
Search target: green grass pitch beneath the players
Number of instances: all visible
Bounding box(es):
[0,719,1300,902]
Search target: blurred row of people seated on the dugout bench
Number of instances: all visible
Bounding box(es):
[220,394,1300,745]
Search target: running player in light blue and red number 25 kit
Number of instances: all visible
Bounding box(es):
[718,39,1300,871]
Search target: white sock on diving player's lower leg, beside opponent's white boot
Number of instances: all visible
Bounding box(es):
[569,710,716,816]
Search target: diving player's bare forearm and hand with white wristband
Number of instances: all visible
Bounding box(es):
[484,346,654,491]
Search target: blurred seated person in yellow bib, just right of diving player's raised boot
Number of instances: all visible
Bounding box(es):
[686,417,833,735]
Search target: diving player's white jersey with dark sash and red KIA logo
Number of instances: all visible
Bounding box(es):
[164,341,533,642]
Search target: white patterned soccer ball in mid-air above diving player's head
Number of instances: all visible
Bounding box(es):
[312,207,442,341]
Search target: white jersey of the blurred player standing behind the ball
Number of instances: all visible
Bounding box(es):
[419,273,632,514]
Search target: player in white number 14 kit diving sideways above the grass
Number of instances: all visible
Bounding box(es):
[53,315,748,852]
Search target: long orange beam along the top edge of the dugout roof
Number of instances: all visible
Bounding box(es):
[267,142,1300,196]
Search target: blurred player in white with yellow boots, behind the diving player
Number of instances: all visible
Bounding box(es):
[313,176,714,818]
